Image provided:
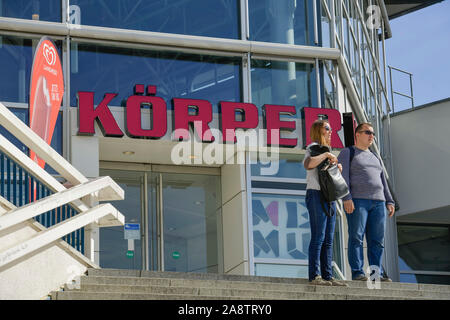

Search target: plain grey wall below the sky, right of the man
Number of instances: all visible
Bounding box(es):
[391,99,450,223]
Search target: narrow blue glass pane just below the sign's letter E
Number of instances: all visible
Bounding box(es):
[251,154,306,179]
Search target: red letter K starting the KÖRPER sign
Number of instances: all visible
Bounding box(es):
[78,92,123,137]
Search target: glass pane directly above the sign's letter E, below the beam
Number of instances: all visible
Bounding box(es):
[251,60,317,110]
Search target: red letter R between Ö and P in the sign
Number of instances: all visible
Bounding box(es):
[172,98,214,142]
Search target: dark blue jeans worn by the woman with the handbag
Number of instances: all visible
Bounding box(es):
[305,189,336,281]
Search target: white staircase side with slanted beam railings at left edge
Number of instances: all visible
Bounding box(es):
[0,103,125,300]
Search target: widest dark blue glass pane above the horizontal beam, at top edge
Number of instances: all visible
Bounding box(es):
[70,0,240,39]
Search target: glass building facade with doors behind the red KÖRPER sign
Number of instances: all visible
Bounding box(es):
[0,0,408,277]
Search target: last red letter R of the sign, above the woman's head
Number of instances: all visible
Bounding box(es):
[303,107,344,148]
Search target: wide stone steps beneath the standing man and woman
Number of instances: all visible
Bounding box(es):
[49,269,450,300]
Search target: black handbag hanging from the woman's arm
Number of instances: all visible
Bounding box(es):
[309,145,350,216]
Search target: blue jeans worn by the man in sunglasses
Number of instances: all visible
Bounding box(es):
[346,199,386,279]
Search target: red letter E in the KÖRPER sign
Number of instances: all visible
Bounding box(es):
[263,104,297,147]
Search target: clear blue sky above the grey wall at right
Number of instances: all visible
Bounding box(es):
[386,0,450,111]
